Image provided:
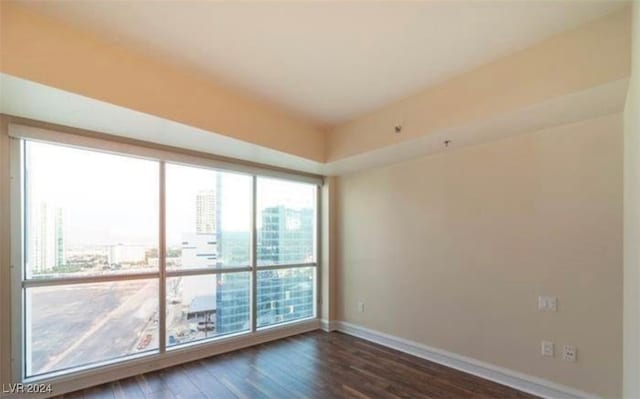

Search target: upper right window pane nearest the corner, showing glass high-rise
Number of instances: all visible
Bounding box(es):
[256,178,316,266]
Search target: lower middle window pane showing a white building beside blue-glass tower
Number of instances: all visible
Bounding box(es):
[167,272,250,346]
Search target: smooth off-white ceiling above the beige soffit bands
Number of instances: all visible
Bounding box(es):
[16,0,625,124]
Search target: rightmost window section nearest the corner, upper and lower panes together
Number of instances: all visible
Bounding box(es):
[256,178,316,327]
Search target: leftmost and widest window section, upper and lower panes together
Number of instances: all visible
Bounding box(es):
[23,141,159,377]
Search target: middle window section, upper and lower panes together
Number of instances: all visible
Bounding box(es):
[166,164,253,347]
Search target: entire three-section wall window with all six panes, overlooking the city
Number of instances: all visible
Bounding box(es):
[13,139,317,378]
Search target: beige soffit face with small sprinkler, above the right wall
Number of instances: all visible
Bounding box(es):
[327,8,631,161]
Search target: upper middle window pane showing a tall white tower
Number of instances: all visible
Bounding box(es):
[166,164,252,269]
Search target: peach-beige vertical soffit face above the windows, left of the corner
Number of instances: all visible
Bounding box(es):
[0,1,325,161]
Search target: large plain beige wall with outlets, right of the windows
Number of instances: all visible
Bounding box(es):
[337,114,623,397]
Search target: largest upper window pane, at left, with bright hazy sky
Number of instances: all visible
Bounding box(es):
[24,141,159,278]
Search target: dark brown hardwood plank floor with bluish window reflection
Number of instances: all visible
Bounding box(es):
[58,331,534,399]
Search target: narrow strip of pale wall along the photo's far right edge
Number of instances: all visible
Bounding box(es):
[624,2,640,399]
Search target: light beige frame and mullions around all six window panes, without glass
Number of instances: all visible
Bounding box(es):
[8,122,323,382]
